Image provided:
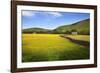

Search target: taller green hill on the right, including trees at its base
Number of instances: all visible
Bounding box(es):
[53,19,90,34]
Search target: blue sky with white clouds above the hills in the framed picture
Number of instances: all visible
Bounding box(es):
[22,10,90,29]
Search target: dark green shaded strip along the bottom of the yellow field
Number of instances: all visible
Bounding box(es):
[22,48,90,62]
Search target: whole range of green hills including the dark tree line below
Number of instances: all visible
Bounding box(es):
[22,19,90,34]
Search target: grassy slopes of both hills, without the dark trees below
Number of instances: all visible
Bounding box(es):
[23,19,90,34]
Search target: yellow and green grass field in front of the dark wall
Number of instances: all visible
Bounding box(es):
[22,34,89,62]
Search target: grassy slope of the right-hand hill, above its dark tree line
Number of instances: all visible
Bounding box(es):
[55,19,90,32]
